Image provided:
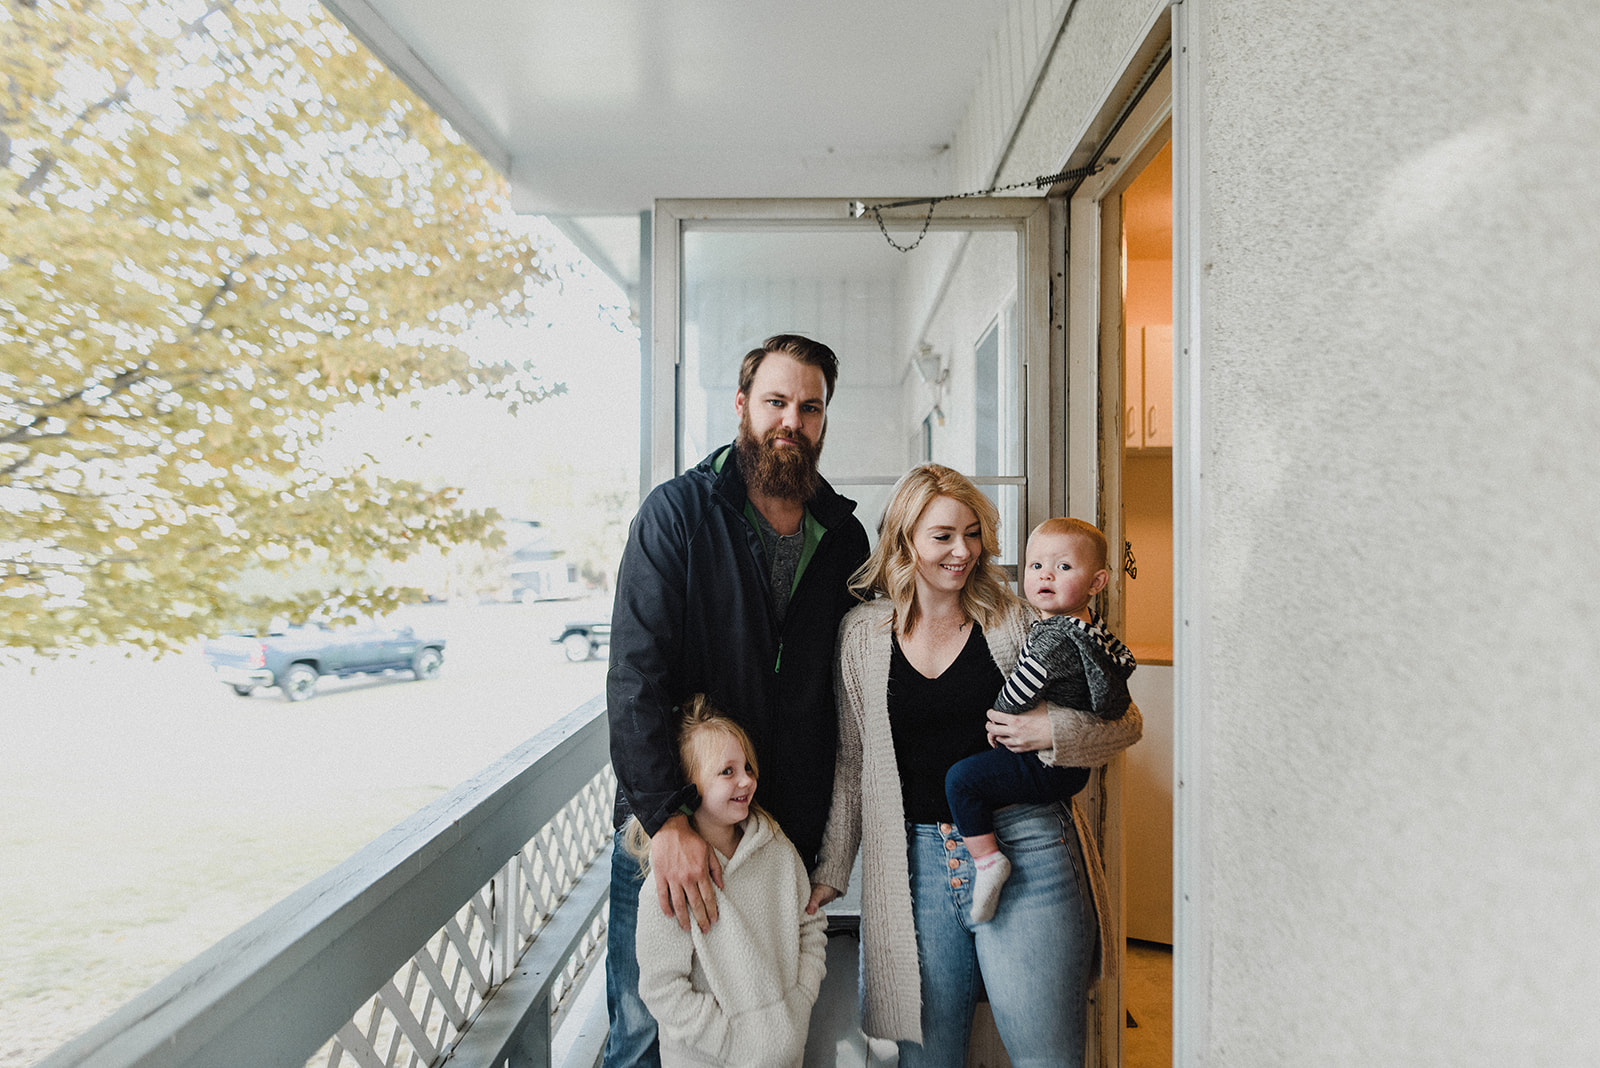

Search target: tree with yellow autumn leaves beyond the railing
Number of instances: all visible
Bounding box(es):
[0,0,560,652]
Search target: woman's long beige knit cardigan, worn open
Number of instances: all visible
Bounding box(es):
[811,600,1144,1042]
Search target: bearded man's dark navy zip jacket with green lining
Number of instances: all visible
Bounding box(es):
[606,448,867,867]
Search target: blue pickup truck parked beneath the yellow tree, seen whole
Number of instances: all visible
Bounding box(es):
[205,624,445,700]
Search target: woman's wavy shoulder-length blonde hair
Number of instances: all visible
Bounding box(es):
[850,464,1016,635]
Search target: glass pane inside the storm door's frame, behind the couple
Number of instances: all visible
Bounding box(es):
[678,224,1024,563]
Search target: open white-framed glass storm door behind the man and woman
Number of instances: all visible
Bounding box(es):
[645,197,1061,574]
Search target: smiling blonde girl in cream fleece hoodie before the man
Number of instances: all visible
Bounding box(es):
[627,695,827,1068]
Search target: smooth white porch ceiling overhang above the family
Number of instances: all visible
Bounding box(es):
[323,0,1006,296]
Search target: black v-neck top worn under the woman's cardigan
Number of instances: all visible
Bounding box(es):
[888,620,1005,823]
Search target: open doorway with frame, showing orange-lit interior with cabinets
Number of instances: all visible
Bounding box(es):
[1067,51,1176,1065]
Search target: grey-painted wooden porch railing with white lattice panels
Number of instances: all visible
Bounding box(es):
[38,699,614,1068]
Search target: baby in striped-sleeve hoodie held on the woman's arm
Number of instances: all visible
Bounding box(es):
[947,518,1134,924]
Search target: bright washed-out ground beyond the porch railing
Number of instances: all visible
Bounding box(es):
[0,600,610,1068]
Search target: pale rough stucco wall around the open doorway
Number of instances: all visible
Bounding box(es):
[1006,0,1600,1066]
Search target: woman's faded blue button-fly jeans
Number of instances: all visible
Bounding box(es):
[899,804,1099,1068]
